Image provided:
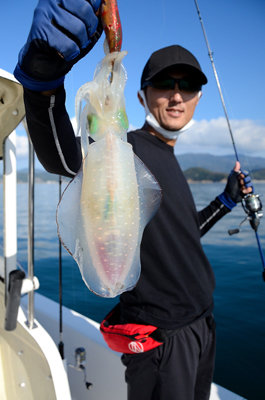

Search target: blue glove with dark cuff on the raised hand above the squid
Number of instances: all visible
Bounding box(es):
[14,0,102,91]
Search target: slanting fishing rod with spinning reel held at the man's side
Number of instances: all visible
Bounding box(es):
[194,0,265,281]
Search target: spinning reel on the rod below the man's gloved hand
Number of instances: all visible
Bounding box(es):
[228,193,263,235]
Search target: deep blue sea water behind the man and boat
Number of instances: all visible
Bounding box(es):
[0,182,265,400]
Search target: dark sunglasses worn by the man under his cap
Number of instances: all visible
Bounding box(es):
[143,76,201,93]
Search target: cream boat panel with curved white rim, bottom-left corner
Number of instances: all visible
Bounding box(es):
[0,283,71,400]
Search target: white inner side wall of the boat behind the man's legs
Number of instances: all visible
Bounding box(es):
[25,294,243,400]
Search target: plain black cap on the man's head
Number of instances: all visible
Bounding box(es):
[141,45,208,89]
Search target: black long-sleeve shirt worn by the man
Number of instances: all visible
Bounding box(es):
[24,88,230,329]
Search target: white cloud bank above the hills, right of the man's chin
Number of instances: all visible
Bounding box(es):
[176,117,265,157]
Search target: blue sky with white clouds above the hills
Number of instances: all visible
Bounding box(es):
[0,0,265,169]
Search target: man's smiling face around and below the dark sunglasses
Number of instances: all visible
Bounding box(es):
[146,72,199,131]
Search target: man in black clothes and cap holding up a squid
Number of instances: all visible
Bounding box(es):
[15,0,252,400]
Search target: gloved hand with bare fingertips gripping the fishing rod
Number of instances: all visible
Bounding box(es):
[218,161,254,210]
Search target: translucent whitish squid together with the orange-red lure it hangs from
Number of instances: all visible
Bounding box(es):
[57,0,161,297]
